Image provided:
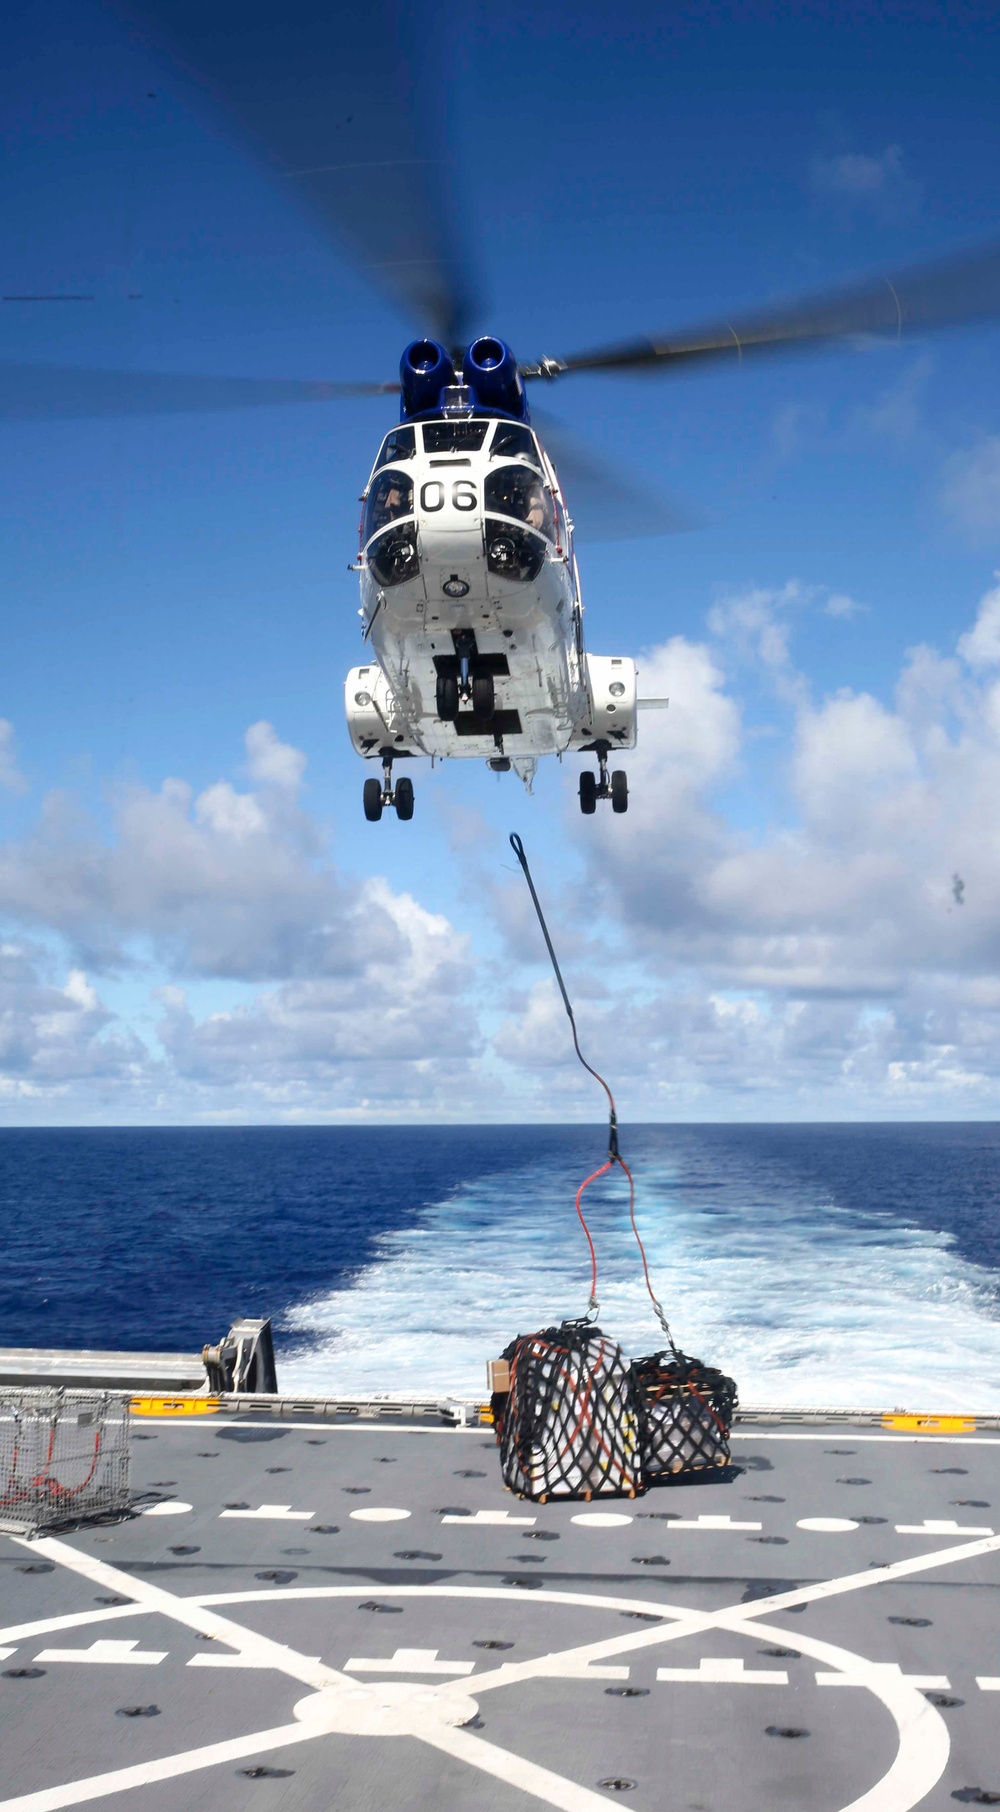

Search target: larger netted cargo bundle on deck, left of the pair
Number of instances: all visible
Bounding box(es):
[496,1321,639,1504]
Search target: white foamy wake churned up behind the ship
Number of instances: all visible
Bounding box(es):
[281,1158,1000,1413]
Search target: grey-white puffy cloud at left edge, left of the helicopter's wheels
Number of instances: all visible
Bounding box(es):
[0,725,378,980]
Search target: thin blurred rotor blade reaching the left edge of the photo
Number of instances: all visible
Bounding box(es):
[0,364,399,422]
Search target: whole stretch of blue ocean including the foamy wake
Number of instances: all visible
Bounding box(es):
[0,1123,1000,1412]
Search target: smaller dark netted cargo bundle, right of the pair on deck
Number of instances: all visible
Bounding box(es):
[632,1350,737,1484]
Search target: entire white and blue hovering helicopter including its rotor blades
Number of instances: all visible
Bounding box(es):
[11,0,1000,821]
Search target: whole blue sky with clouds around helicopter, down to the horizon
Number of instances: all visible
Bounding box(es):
[0,0,1000,1123]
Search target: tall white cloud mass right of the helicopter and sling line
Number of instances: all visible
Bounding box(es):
[518,576,1000,1118]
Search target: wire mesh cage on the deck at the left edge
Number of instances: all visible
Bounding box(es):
[0,1390,130,1535]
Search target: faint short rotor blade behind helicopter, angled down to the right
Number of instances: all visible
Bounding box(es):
[531,410,696,542]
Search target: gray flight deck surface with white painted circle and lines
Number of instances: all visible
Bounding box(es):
[0,1415,1000,1812]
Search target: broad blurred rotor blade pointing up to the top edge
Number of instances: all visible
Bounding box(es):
[121,0,476,346]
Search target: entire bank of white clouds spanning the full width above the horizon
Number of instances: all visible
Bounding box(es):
[13,582,1000,1120]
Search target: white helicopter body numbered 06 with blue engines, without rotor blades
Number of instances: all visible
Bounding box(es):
[346,339,636,819]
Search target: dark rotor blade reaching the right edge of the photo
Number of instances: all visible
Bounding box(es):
[520,243,1000,377]
